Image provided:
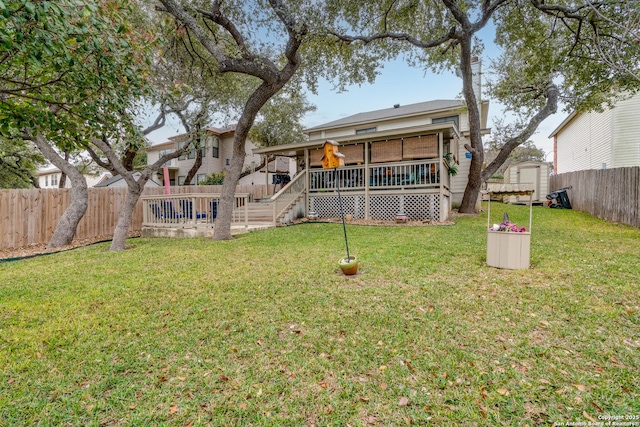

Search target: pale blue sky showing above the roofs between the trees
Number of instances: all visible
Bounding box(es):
[145,26,567,161]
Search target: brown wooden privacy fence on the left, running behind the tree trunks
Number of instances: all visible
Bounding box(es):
[0,185,272,249]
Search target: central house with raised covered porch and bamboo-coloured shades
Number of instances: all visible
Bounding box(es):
[254,93,489,221]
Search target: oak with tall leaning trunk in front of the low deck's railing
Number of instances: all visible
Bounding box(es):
[158,0,376,240]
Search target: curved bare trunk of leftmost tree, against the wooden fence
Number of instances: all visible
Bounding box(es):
[34,135,89,249]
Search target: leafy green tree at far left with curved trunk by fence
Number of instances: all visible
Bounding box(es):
[0,0,157,247]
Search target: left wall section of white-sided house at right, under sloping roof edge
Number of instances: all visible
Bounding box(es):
[556,111,612,173]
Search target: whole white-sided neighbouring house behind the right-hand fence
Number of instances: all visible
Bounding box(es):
[549,94,640,174]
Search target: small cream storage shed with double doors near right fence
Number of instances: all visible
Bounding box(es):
[504,162,551,204]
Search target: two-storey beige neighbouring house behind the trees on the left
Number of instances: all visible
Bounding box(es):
[147,126,295,185]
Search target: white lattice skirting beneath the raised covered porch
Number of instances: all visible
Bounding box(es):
[309,194,449,221]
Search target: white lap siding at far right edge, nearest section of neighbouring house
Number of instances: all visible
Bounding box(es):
[609,96,640,168]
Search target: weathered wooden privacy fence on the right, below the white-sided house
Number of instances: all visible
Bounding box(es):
[549,166,640,227]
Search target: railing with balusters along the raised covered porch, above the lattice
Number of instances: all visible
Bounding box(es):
[310,159,440,192]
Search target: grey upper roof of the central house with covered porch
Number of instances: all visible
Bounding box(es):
[305,99,466,132]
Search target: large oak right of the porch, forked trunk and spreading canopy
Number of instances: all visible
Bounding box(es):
[324,0,638,213]
